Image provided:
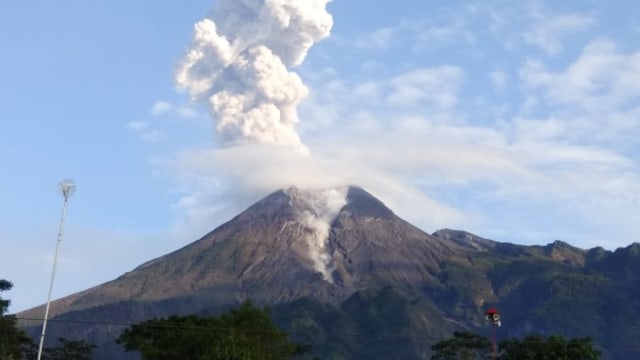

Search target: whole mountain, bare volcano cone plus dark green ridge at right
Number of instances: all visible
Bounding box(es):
[18,187,640,359]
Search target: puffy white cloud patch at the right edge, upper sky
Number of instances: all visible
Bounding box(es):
[520,39,640,144]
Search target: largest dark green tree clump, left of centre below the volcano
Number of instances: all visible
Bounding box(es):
[116,302,309,360]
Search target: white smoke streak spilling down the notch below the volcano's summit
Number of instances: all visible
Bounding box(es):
[289,187,348,283]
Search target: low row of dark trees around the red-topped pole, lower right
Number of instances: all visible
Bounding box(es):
[431,332,601,360]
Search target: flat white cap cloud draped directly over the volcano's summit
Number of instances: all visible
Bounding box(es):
[165,139,473,235]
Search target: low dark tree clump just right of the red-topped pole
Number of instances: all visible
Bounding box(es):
[499,335,601,360]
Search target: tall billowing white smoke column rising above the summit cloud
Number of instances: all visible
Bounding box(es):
[176,0,333,146]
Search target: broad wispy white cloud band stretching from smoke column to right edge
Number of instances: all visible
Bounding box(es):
[302,56,640,244]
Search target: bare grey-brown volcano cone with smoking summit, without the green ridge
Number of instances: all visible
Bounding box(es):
[21,187,464,315]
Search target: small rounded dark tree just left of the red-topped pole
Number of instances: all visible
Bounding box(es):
[431,331,493,360]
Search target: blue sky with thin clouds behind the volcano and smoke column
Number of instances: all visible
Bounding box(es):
[0,0,640,311]
